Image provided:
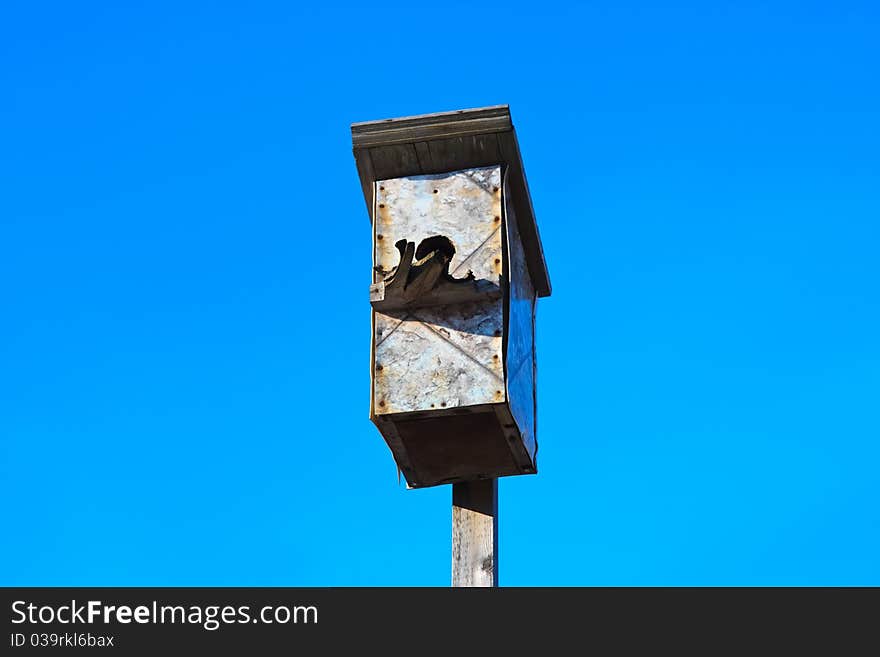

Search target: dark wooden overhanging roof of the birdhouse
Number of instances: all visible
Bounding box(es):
[351,105,551,297]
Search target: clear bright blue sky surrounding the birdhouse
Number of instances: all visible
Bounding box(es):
[0,1,880,586]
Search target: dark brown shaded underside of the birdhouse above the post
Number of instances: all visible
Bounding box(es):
[373,403,537,488]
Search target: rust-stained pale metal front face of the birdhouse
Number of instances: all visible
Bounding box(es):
[373,166,506,415]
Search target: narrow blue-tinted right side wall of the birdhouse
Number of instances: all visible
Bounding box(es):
[504,184,538,463]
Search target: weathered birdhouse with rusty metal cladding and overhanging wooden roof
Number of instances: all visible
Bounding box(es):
[351,105,550,488]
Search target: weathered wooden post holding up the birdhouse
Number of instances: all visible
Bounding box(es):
[452,479,498,587]
